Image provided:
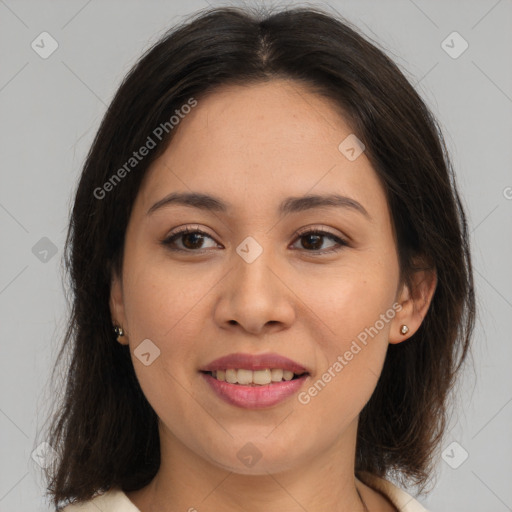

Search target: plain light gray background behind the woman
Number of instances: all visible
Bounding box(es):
[0,0,512,512]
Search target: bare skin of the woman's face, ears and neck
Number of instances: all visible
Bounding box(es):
[110,80,435,512]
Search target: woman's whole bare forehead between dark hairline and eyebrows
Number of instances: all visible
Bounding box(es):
[136,80,383,222]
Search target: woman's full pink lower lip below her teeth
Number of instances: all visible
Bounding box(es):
[201,372,309,409]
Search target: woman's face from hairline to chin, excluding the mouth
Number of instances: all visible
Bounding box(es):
[111,81,403,474]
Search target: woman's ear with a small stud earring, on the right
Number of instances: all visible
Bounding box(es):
[389,268,437,344]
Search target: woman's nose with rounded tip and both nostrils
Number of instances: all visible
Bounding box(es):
[215,244,296,335]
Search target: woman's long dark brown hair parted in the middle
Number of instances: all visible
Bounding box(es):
[40,3,475,508]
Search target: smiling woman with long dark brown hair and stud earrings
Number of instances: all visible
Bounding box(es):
[42,8,474,512]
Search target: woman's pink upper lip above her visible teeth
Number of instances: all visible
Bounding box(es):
[201,353,309,374]
